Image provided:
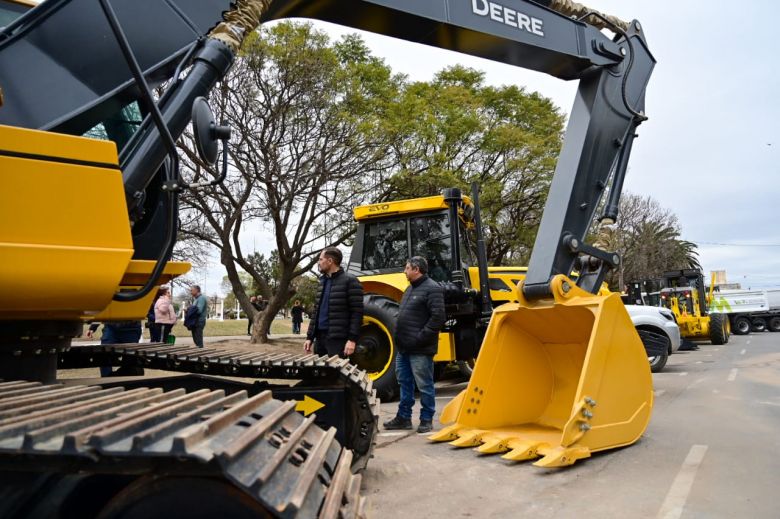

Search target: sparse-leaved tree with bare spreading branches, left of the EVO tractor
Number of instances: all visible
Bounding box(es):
[181,23,399,342]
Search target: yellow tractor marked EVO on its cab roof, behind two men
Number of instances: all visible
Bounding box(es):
[347,188,526,400]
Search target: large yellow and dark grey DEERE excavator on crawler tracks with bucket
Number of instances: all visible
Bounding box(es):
[0,0,654,518]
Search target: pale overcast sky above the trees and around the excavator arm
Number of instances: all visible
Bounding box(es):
[193,0,780,293]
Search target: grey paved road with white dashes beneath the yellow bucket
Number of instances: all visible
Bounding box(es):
[363,332,780,519]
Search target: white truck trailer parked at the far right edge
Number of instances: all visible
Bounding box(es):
[709,289,780,335]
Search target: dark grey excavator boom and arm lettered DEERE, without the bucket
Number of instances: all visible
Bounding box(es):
[0,0,655,276]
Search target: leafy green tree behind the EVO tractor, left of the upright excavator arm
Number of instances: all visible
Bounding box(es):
[383,66,564,265]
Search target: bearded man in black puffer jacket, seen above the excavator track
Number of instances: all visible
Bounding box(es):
[303,247,363,357]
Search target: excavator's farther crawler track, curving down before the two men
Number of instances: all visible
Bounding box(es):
[58,343,379,472]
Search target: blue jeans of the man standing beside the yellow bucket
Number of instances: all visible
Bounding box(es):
[395,351,436,421]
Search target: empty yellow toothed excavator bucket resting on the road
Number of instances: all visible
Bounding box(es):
[430,276,653,467]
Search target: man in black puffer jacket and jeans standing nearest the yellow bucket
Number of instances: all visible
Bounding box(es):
[384,256,446,433]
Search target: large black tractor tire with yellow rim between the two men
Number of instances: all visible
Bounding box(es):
[350,294,399,402]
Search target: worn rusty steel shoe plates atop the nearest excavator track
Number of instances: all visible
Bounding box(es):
[0,381,363,518]
